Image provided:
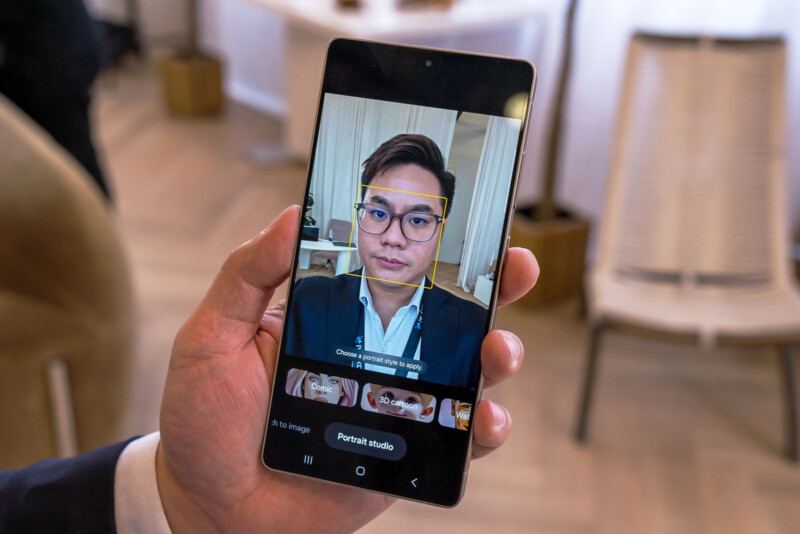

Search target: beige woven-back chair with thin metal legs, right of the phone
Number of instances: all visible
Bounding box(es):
[575,34,800,461]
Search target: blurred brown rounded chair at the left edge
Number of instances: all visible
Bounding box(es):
[0,96,134,469]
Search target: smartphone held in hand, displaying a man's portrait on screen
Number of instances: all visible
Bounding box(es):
[262,39,535,506]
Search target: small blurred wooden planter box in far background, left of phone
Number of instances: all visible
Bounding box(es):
[158,54,223,117]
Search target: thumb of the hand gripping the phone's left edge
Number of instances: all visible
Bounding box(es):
[181,206,300,352]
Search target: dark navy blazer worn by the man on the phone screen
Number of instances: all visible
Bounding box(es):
[286,271,488,387]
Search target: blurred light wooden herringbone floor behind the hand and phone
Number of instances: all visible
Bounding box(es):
[96,61,800,534]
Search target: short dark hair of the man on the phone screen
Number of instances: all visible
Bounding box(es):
[361,134,456,218]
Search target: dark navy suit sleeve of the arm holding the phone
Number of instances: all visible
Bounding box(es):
[0,441,135,534]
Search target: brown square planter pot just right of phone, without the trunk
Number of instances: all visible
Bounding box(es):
[511,206,589,307]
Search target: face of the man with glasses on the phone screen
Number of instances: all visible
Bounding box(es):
[358,164,443,285]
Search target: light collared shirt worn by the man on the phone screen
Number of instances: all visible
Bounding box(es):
[358,276,425,379]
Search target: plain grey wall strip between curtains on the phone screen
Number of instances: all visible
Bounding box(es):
[439,113,489,263]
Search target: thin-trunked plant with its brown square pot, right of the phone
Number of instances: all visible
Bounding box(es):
[511,0,589,306]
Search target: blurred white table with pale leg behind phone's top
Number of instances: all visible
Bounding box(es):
[241,0,548,160]
